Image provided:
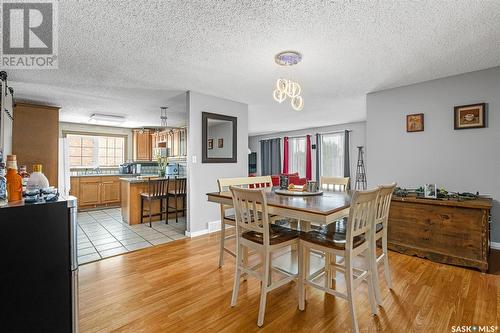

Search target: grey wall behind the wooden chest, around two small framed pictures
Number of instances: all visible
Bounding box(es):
[367,67,500,242]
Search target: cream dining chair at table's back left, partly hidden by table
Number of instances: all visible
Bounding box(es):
[217,176,273,267]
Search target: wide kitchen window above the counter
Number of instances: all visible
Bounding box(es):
[67,134,125,168]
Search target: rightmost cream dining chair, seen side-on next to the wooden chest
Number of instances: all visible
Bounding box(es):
[371,183,396,304]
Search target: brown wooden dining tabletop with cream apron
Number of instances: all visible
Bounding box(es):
[207,187,351,225]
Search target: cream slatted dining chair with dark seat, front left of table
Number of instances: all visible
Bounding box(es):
[231,187,299,327]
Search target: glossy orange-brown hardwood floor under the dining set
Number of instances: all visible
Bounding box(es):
[80,234,500,333]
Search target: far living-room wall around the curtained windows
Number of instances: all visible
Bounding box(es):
[248,121,366,184]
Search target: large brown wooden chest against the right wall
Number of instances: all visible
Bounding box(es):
[387,197,492,272]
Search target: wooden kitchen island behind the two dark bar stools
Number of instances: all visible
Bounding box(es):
[120,176,185,225]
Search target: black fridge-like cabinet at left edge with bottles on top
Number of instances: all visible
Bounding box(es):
[0,197,78,333]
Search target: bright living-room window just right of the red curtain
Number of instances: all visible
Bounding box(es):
[320,133,344,177]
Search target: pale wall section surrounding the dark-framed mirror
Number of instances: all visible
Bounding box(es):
[187,91,248,235]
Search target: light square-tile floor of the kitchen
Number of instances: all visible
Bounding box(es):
[78,208,186,265]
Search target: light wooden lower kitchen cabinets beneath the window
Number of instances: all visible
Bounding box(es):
[70,176,121,210]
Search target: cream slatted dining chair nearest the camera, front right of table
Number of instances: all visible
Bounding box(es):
[298,188,379,332]
